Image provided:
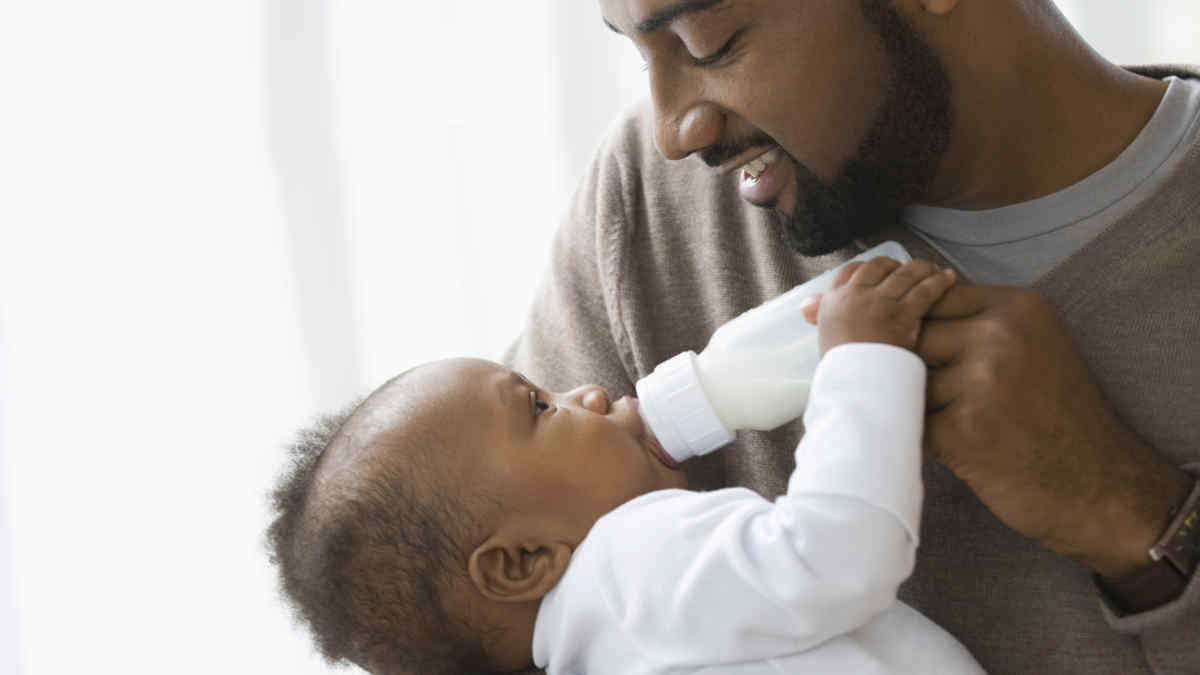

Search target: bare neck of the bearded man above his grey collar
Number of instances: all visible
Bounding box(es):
[923,2,1166,210]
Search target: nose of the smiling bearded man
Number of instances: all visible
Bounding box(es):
[650,68,725,160]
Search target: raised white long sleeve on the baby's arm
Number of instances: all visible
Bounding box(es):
[588,345,925,667]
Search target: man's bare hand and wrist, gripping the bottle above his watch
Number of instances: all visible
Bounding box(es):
[916,283,1192,577]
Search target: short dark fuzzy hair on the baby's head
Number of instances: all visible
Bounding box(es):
[266,389,496,675]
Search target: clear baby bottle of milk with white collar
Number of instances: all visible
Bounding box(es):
[637,241,912,461]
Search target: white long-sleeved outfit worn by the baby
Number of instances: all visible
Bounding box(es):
[533,344,983,675]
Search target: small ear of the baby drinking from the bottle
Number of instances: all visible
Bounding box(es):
[467,536,571,603]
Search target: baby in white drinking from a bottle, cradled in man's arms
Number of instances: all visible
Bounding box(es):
[269,258,983,675]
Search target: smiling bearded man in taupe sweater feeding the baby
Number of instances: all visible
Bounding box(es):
[508,0,1200,674]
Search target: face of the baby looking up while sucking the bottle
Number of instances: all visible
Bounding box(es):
[422,359,686,544]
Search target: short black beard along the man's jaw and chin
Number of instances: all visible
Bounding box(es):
[768,0,950,256]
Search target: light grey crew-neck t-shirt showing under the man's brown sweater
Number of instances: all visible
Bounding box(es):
[904,77,1200,286]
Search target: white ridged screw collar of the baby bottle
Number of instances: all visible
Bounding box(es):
[637,352,733,462]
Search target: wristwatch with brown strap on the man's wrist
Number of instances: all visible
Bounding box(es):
[1096,480,1200,614]
